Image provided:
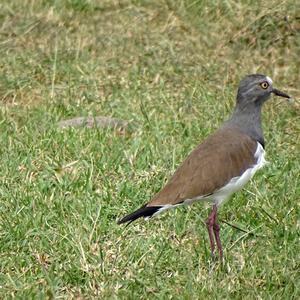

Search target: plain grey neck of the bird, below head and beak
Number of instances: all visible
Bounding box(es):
[224,103,264,146]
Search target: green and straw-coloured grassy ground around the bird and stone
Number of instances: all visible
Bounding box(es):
[0,0,300,299]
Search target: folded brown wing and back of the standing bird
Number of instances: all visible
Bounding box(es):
[147,128,257,207]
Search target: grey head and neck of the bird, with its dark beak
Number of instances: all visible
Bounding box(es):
[223,74,290,146]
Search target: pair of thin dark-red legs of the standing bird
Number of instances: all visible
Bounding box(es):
[206,205,223,259]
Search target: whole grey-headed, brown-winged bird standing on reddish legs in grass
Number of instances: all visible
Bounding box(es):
[118,74,290,260]
